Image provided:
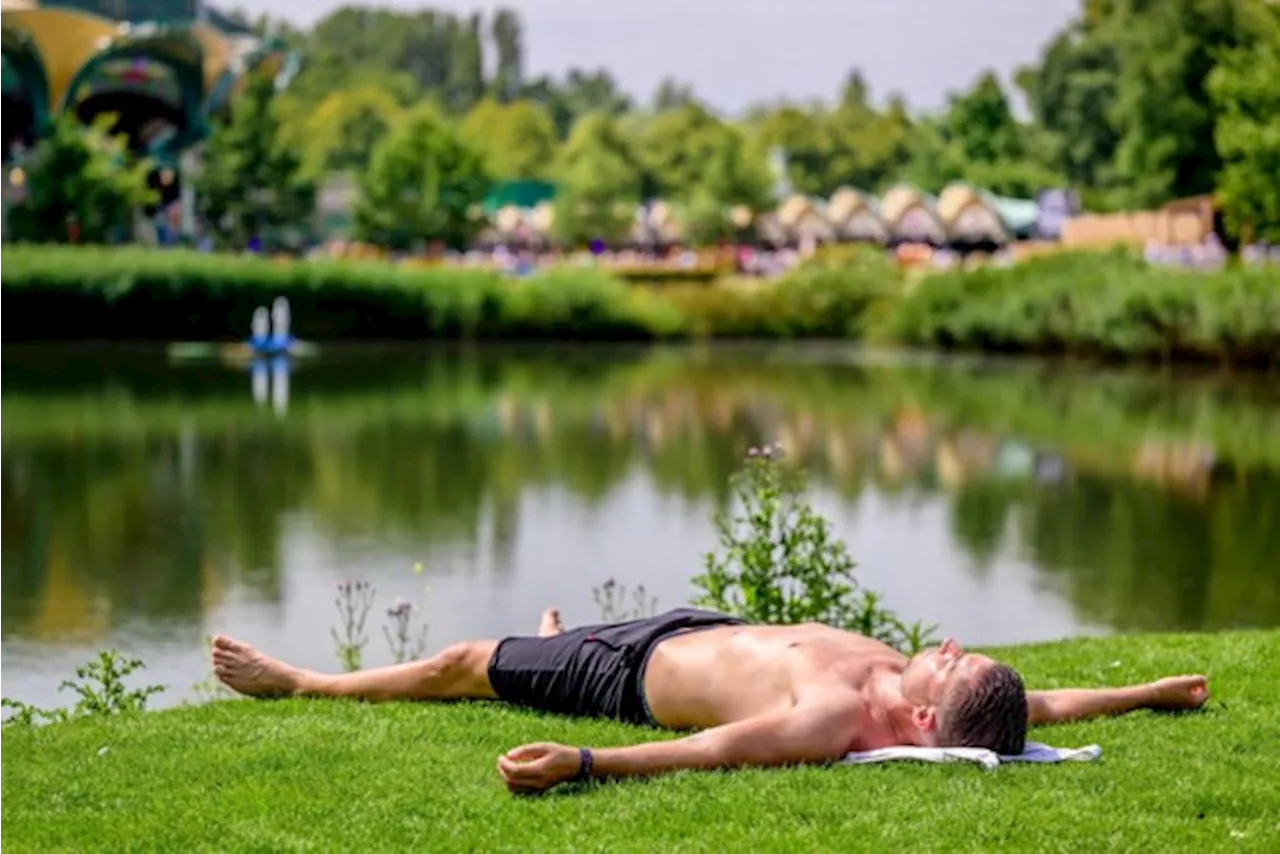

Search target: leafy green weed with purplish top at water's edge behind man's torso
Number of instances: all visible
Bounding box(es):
[694,446,937,653]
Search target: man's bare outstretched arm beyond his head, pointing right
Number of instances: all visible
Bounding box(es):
[1027,676,1208,726]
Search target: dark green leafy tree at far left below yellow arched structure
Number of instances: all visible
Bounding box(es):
[12,114,154,243]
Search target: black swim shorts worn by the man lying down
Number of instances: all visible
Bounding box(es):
[489,608,744,725]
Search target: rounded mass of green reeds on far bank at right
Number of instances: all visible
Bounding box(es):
[887,251,1280,364]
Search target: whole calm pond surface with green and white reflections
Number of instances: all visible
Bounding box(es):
[0,346,1280,705]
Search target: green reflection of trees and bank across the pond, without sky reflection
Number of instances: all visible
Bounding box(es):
[0,350,1280,635]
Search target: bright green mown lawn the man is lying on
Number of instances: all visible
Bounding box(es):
[0,631,1280,851]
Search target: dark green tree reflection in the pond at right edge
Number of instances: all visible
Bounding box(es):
[952,472,1280,630]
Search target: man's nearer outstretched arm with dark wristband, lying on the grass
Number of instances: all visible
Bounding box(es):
[498,704,851,793]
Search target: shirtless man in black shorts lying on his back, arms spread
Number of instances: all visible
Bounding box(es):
[212,608,1208,793]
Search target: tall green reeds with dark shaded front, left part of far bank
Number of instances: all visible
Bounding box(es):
[0,247,682,342]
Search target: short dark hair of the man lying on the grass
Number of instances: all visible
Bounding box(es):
[938,665,1027,757]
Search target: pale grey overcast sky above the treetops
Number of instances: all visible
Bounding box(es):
[238,0,1080,111]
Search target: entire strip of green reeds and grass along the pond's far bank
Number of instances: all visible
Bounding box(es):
[0,247,1280,365]
